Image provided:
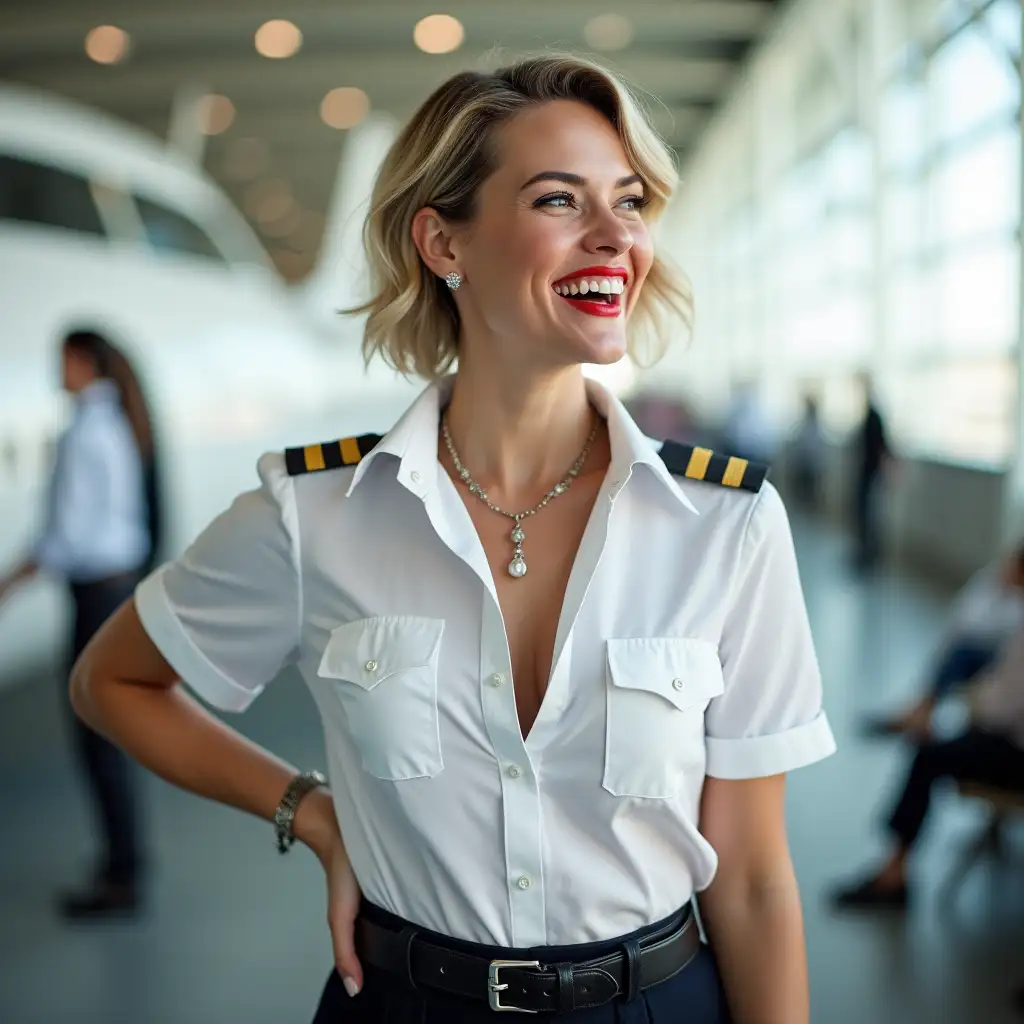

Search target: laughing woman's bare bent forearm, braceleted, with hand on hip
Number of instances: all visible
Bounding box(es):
[72,664,338,859]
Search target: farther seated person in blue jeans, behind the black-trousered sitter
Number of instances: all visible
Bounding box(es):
[867,544,1024,739]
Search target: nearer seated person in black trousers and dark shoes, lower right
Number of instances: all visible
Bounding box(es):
[831,627,1024,908]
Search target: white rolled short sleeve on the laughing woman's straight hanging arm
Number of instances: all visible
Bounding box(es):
[705,483,836,779]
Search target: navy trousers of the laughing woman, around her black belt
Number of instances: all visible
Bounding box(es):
[313,906,731,1024]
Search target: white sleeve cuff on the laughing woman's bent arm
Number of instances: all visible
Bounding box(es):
[135,565,262,712]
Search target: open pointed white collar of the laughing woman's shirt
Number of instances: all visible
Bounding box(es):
[346,375,699,515]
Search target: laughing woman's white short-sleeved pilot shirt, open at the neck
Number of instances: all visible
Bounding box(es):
[136,378,835,946]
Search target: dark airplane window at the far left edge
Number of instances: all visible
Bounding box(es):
[0,156,103,236]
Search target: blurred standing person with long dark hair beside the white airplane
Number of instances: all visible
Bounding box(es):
[0,331,160,919]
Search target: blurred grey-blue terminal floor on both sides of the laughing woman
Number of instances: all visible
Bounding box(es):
[0,521,1024,1024]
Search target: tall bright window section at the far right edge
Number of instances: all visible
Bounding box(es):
[881,2,1021,466]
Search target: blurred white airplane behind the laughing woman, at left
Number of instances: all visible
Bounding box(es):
[0,84,418,687]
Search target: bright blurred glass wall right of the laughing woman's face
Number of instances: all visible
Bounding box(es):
[670,0,1022,468]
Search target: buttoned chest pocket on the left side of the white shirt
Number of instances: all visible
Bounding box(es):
[317,615,444,782]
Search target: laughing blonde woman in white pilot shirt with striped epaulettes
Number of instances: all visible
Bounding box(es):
[72,55,835,1024]
